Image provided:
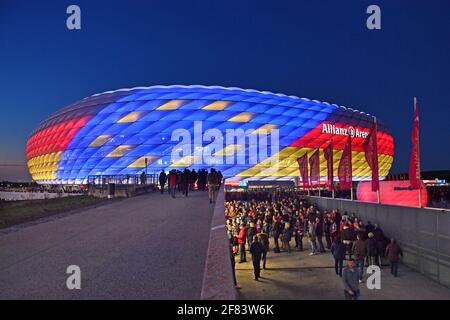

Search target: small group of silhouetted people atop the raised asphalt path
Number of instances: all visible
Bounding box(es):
[158,168,223,203]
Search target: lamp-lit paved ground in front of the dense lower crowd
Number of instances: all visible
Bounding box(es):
[236,245,450,300]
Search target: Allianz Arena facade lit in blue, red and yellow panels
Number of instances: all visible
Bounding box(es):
[26,86,394,184]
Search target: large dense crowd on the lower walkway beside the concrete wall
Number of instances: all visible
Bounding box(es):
[225,191,402,299]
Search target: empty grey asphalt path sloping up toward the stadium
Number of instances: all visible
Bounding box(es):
[0,192,213,299]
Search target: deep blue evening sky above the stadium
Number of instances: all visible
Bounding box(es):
[0,0,450,180]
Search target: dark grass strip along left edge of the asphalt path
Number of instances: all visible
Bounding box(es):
[0,196,106,229]
